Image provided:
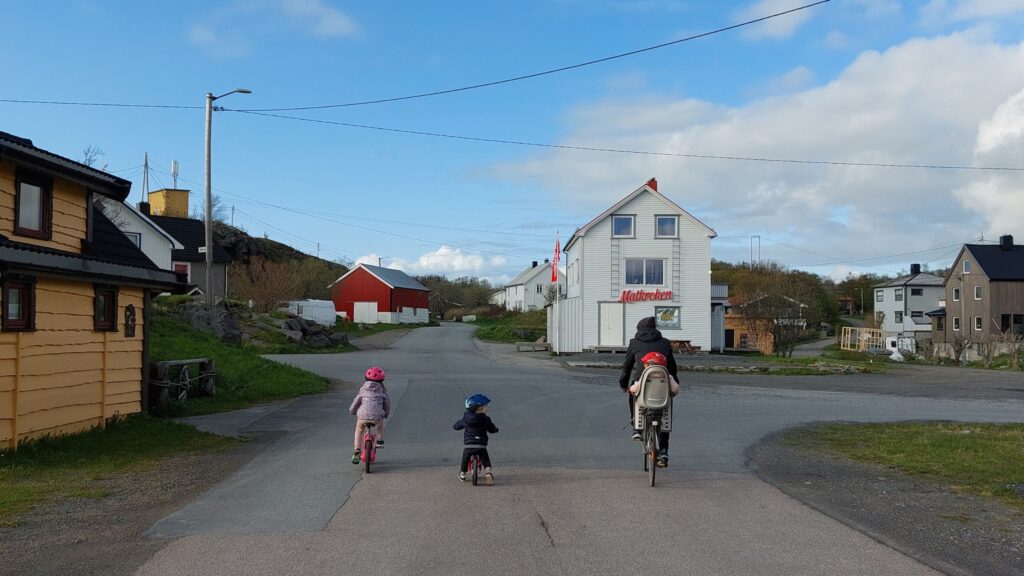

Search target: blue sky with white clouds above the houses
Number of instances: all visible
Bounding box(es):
[0,0,1024,285]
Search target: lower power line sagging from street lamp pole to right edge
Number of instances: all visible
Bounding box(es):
[230,109,1024,172]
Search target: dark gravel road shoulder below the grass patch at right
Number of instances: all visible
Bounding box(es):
[750,431,1024,575]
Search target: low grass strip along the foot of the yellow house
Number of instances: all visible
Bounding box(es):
[0,414,237,526]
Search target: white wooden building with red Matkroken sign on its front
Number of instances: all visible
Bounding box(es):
[548,178,724,353]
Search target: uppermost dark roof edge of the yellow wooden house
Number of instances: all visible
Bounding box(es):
[0,132,131,201]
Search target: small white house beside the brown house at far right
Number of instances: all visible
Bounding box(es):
[873,264,946,339]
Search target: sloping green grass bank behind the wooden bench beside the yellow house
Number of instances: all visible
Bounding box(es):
[150,315,328,416]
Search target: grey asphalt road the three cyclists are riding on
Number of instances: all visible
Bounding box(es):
[138,325,1024,575]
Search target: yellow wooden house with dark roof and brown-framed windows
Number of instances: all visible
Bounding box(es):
[0,132,181,449]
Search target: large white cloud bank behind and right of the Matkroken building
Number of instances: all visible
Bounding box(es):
[495,34,1024,273]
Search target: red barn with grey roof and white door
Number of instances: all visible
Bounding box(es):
[330,264,430,324]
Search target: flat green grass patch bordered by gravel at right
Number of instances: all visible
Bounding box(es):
[786,422,1024,508]
